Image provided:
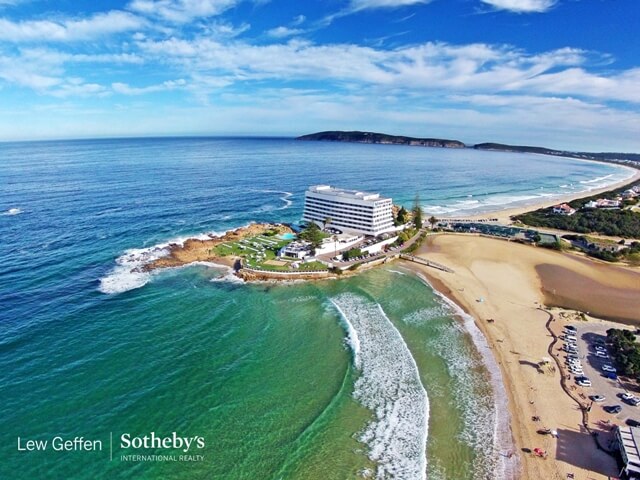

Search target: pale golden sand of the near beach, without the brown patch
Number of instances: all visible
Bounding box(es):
[403,234,640,479]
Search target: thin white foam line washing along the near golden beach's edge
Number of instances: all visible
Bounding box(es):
[417,273,520,480]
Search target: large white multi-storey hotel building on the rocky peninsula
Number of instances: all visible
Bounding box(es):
[302,185,395,236]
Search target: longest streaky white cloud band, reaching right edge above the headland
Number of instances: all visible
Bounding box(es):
[138,38,640,102]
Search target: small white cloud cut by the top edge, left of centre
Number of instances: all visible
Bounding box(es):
[128,0,241,23]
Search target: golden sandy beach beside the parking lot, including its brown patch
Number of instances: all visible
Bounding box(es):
[404,234,640,479]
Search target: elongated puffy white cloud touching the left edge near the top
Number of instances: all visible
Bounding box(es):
[0,10,144,43]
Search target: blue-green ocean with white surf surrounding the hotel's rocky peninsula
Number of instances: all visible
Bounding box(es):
[0,138,629,480]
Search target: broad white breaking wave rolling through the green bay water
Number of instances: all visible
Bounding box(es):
[331,293,429,479]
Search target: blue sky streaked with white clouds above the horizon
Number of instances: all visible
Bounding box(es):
[0,0,640,152]
